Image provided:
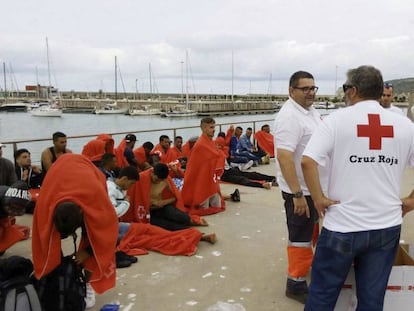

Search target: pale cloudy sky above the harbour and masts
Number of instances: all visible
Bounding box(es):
[0,0,414,95]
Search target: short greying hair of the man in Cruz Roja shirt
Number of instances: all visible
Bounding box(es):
[347,66,384,100]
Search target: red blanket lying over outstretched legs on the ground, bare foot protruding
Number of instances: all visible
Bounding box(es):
[119,223,201,256]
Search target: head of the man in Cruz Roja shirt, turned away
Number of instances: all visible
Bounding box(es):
[343,66,384,105]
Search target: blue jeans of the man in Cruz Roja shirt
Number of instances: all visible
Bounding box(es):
[305,225,401,311]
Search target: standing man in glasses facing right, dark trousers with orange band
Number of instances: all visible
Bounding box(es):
[274,71,322,303]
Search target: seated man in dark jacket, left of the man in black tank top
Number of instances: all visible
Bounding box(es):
[14,148,43,214]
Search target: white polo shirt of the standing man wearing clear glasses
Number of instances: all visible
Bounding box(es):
[273,98,327,195]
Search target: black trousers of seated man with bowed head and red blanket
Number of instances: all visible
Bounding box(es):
[150,205,191,231]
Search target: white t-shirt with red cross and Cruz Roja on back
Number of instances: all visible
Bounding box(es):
[303,100,414,232]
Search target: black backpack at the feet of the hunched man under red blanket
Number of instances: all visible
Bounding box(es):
[34,235,86,311]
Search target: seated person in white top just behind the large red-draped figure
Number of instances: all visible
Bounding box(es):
[106,166,139,268]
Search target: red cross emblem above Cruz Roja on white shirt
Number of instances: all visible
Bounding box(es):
[357,114,394,150]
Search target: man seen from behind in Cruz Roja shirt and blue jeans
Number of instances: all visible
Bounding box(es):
[302,66,414,311]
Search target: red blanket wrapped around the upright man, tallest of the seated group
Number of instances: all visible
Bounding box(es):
[181,135,225,215]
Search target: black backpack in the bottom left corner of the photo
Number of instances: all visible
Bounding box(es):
[0,256,42,311]
